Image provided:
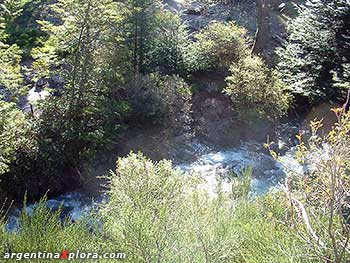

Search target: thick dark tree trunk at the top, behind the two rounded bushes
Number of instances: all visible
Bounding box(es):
[252,0,271,55]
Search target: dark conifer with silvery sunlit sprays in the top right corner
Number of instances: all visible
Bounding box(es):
[279,0,350,102]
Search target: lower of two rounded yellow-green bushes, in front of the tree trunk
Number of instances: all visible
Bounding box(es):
[224,56,290,121]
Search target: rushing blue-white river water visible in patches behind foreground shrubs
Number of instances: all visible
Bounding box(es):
[7,120,304,231]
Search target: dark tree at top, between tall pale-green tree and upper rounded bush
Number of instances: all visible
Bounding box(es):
[121,0,188,79]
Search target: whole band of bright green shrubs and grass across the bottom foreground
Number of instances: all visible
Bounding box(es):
[0,154,345,263]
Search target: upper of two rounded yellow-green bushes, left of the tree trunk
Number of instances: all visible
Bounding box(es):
[186,22,249,71]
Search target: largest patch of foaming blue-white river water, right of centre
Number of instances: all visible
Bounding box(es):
[179,144,303,195]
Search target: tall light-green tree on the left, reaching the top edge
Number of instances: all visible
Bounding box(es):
[33,0,129,166]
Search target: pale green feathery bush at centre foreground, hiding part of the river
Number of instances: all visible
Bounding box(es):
[102,154,196,262]
